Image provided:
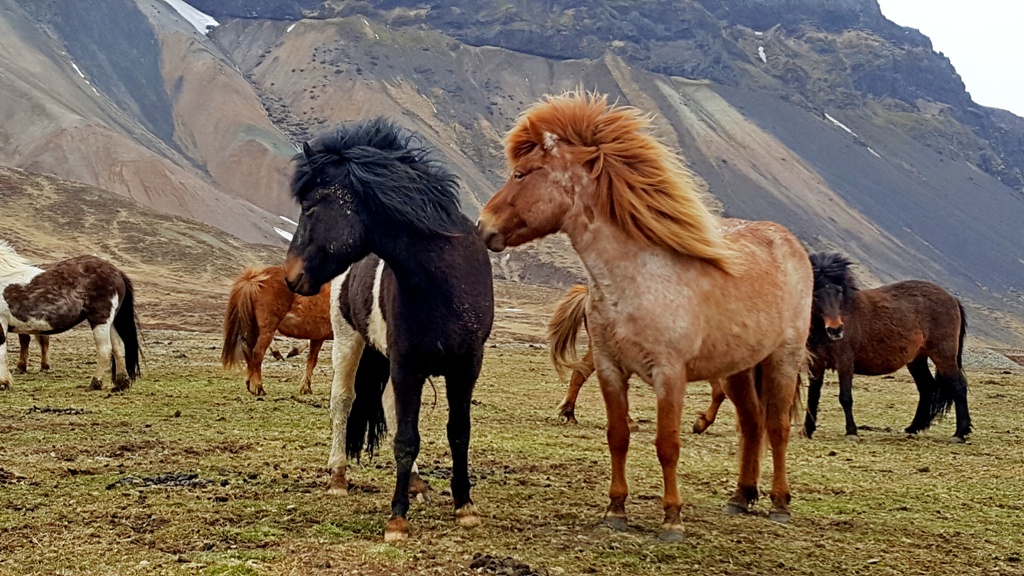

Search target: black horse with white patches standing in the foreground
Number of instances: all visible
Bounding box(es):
[285,118,494,541]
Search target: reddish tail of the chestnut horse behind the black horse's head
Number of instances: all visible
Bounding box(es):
[220,266,270,369]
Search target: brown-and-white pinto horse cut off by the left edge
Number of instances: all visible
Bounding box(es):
[0,240,140,392]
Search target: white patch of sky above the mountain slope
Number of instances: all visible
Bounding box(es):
[879,0,1024,117]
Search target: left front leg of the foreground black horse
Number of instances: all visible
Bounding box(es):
[384,360,425,542]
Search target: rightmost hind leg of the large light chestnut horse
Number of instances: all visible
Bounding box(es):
[761,349,804,524]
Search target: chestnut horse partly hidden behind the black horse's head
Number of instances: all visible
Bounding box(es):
[220,266,334,396]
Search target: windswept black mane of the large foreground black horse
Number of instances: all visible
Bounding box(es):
[292,118,470,235]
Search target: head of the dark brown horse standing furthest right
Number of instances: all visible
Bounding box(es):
[810,252,857,340]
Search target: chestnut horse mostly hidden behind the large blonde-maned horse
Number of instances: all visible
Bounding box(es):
[548,284,725,434]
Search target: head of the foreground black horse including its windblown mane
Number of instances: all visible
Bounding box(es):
[285,118,468,296]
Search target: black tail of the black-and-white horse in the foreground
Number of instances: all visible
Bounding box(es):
[345,345,391,460]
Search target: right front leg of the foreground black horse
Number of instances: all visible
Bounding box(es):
[444,355,482,528]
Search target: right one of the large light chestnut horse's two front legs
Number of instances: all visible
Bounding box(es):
[654,370,686,542]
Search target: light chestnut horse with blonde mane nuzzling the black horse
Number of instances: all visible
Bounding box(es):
[478,91,813,541]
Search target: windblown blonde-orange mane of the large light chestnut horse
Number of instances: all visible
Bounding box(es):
[505,89,740,273]
